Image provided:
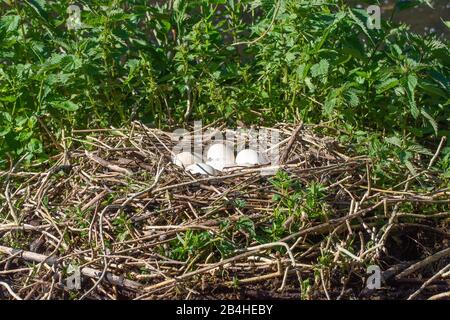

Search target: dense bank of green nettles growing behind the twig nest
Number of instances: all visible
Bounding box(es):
[0,0,450,176]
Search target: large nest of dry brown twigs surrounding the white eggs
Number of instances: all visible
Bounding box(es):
[0,123,450,299]
